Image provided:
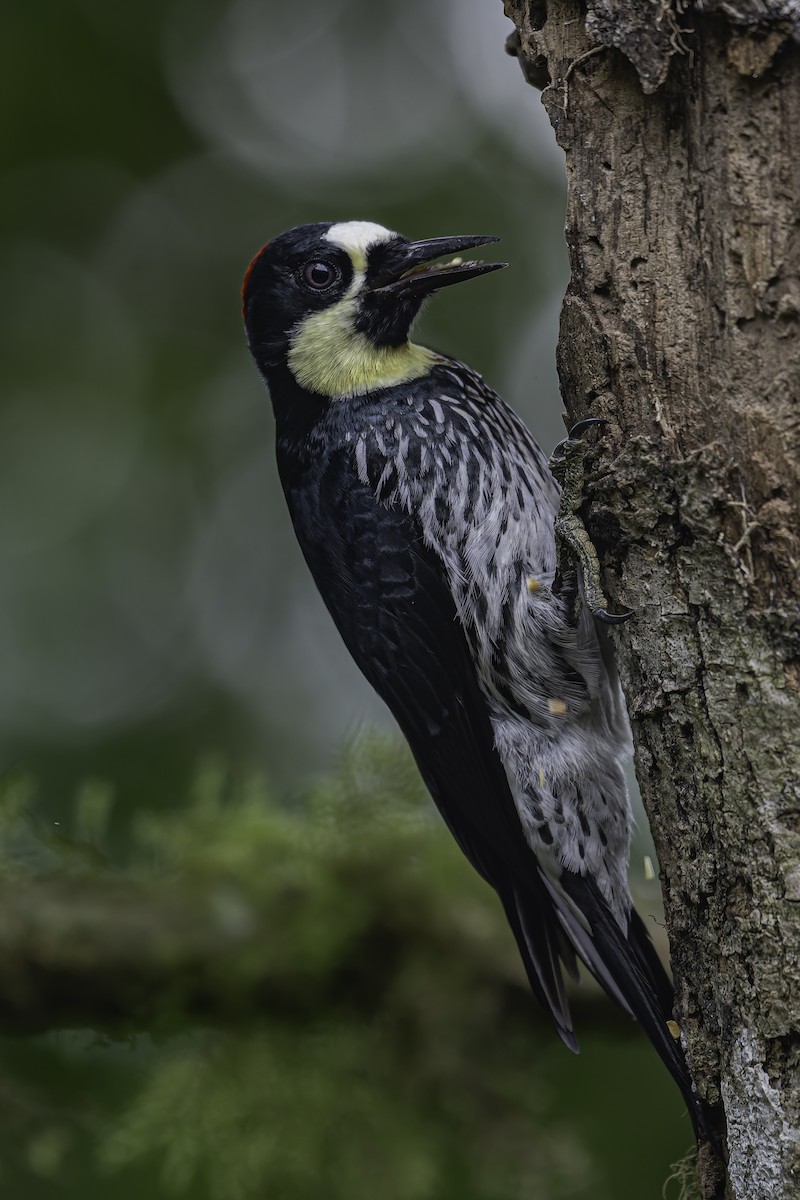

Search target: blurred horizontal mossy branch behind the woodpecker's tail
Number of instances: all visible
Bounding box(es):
[0,872,632,1033]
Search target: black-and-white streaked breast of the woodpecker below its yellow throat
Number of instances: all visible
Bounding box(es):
[345,397,558,673]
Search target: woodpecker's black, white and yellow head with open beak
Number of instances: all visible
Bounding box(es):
[242,221,505,396]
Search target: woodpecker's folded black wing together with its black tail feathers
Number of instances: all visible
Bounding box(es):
[284,450,708,1133]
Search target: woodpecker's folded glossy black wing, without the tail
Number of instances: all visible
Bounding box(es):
[287,452,577,1050]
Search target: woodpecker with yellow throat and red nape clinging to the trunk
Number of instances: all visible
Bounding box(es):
[242,220,708,1140]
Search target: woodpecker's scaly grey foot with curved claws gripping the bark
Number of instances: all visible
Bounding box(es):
[549,416,633,625]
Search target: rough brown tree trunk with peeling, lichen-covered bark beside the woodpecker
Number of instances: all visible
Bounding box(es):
[506,0,800,1200]
